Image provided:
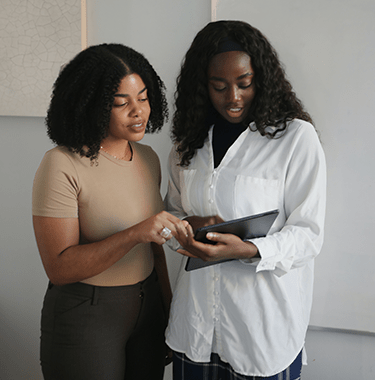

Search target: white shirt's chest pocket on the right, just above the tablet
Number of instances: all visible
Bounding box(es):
[234,175,283,218]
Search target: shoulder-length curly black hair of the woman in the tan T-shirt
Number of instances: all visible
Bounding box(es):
[45,44,168,161]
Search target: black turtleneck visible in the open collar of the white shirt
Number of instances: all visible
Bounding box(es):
[212,118,247,168]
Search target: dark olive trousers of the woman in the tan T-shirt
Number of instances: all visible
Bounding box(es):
[40,270,167,380]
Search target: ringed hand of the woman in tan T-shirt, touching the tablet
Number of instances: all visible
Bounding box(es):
[130,211,189,245]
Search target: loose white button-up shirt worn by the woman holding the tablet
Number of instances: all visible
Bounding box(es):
[165,120,326,376]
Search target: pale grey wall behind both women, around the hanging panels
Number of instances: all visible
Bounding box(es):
[0,0,375,380]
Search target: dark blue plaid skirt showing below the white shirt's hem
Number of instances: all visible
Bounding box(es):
[173,351,302,380]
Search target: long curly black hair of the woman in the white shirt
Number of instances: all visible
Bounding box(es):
[171,20,313,166]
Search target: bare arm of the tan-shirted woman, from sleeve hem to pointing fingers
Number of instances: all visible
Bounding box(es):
[33,212,186,285]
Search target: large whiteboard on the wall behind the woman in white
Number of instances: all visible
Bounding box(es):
[212,0,375,332]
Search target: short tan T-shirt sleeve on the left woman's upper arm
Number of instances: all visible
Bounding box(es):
[32,149,79,218]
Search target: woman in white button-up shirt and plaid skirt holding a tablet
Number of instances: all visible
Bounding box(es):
[165,21,326,380]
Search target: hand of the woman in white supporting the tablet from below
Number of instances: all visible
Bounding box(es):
[176,225,260,261]
